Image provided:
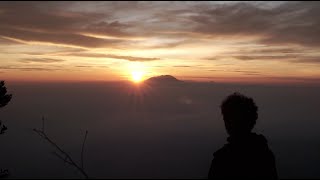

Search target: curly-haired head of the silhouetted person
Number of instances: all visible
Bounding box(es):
[221,92,258,135]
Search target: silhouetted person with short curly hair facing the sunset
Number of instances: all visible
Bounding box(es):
[208,93,278,179]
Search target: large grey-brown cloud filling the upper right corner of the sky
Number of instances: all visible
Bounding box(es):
[189,2,320,47]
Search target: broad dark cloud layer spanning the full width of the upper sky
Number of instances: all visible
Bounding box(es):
[0,2,320,48]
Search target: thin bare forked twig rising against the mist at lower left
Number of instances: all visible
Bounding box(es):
[33,118,89,179]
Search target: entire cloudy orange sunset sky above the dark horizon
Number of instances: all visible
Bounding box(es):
[0,1,320,84]
